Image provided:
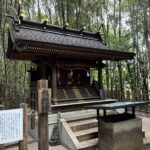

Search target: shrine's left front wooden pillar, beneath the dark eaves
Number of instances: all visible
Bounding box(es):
[52,64,57,100]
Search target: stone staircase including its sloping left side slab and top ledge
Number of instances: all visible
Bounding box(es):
[59,106,117,150]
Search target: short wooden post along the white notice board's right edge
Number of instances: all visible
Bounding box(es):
[19,103,28,150]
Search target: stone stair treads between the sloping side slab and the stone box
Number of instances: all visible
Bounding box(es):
[68,118,98,150]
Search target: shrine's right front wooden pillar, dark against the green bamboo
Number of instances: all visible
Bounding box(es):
[98,63,105,99]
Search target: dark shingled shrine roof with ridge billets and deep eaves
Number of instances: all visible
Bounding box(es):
[7,20,135,60]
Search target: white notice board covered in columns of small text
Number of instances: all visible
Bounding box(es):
[0,109,23,144]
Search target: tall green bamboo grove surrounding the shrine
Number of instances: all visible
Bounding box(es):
[0,0,150,99]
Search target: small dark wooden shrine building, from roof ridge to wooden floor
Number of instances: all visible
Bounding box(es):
[7,19,135,111]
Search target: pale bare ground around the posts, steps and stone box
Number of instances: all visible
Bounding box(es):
[7,117,150,150]
